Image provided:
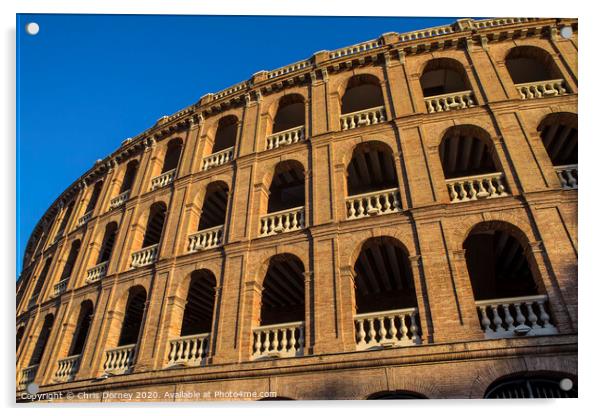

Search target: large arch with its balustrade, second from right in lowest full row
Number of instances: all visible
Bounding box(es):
[354,237,421,349]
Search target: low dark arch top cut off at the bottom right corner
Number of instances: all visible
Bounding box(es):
[484,372,578,399]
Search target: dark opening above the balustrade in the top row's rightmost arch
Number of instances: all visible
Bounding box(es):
[506,46,562,84]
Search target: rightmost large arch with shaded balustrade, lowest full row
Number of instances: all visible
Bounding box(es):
[463,222,556,338]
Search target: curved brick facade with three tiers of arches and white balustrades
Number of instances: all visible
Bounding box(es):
[17,18,577,401]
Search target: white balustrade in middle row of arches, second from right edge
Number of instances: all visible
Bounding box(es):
[445,172,508,203]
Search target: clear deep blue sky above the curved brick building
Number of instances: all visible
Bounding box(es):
[17,14,457,273]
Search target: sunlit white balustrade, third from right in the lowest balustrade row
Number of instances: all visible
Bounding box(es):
[253,322,305,358]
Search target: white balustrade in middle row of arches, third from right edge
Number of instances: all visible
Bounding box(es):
[346,188,401,220]
